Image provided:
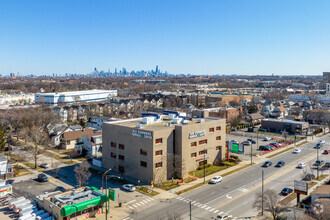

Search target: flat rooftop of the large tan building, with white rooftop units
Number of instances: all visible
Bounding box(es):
[106,115,224,131]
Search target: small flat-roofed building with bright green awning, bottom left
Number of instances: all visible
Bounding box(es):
[36,187,108,220]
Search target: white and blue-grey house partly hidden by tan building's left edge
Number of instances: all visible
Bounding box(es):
[75,133,102,158]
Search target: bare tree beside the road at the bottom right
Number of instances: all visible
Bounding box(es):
[253,189,286,220]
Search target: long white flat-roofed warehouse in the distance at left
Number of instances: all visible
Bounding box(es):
[34,89,117,106]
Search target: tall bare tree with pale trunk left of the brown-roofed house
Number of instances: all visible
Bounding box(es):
[27,126,49,169]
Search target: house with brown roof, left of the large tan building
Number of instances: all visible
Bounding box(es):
[60,128,94,149]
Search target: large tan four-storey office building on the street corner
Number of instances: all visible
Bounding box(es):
[102,112,226,183]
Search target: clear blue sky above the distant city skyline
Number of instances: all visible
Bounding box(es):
[0,0,330,75]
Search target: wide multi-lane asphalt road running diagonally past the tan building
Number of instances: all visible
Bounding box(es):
[130,135,330,220]
